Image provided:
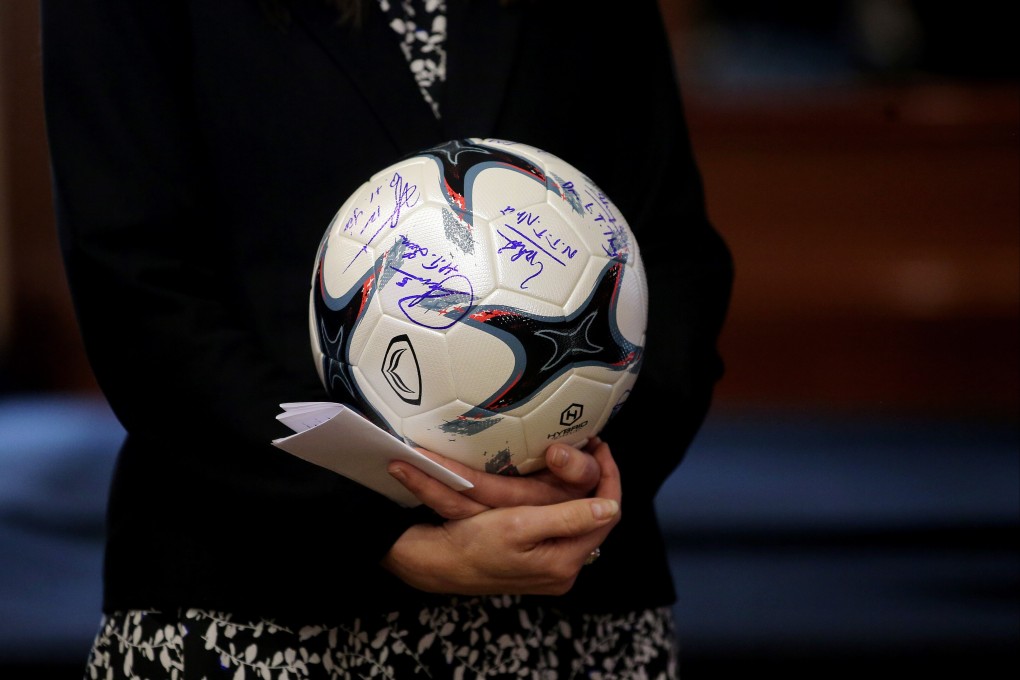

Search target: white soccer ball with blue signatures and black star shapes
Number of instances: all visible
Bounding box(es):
[308,139,648,475]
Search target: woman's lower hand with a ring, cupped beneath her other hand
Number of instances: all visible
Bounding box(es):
[383,442,622,595]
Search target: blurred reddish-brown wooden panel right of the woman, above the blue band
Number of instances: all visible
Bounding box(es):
[691,84,1020,417]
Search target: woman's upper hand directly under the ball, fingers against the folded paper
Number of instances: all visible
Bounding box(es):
[389,437,608,519]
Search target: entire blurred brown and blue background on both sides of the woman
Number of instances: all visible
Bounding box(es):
[0,0,1020,680]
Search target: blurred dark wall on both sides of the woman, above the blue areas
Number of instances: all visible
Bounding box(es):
[0,0,1020,417]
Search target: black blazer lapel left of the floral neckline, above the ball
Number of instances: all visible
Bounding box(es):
[291,0,442,153]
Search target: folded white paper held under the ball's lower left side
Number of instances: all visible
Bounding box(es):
[272,402,473,508]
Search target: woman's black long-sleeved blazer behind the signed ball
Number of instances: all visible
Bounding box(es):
[43,0,731,617]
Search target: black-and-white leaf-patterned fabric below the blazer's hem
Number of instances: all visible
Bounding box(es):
[85,596,677,680]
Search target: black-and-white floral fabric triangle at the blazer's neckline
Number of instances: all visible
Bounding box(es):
[379,0,447,118]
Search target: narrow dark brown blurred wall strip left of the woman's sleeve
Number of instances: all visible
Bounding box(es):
[0,0,96,394]
